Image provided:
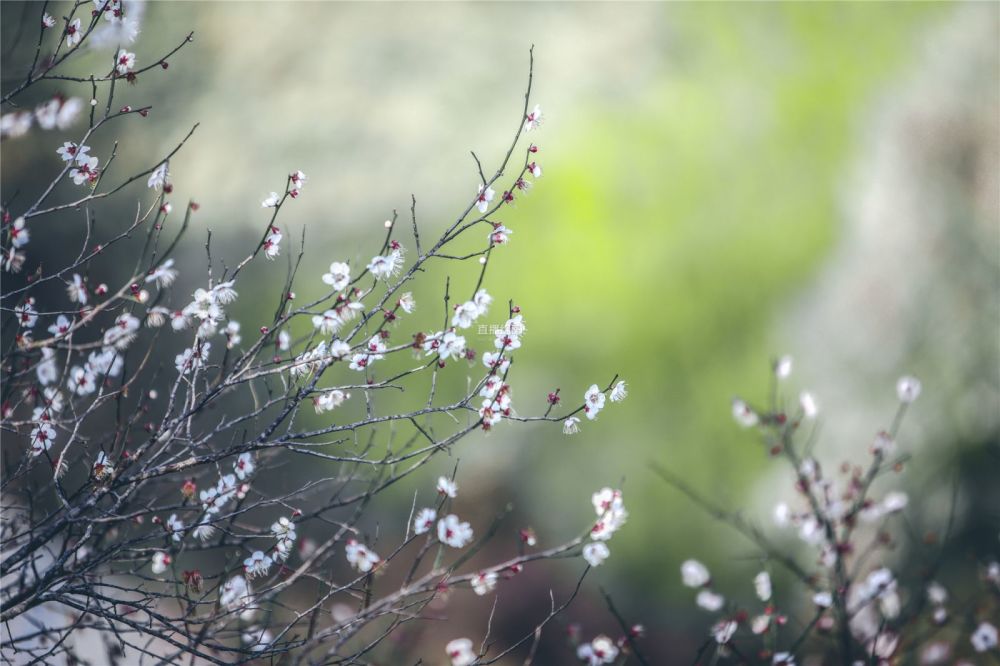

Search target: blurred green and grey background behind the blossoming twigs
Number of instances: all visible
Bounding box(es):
[0,2,1000,664]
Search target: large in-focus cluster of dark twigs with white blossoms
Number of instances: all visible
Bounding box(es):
[0,6,627,664]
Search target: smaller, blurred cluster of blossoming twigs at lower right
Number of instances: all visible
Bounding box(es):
[657,356,1000,665]
